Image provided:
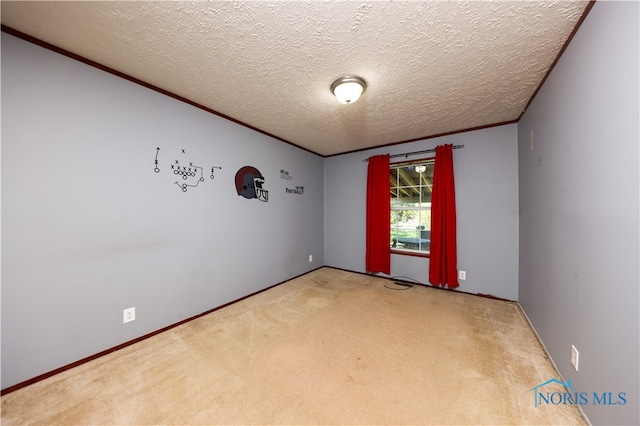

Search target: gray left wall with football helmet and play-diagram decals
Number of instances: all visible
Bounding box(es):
[2,33,324,388]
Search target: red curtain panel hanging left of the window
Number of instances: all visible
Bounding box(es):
[366,154,391,275]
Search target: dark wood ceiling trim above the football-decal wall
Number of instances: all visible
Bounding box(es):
[0,24,324,157]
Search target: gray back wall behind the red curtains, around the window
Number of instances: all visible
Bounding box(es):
[324,124,518,300]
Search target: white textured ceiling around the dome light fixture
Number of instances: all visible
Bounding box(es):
[1,0,588,155]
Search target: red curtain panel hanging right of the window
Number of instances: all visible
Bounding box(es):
[429,144,459,288]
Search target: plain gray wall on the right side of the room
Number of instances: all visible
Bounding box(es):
[518,2,640,424]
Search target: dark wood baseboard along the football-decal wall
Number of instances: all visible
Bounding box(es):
[0,266,323,396]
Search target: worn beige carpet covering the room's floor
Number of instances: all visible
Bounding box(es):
[2,268,584,425]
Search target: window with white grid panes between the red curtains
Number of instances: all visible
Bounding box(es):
[389,159,434,255]
